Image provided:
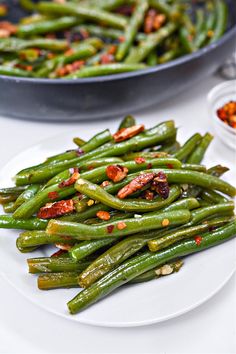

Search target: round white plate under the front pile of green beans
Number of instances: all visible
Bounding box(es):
[0,126,236,327]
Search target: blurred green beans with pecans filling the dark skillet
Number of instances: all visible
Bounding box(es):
[0,0,228,79]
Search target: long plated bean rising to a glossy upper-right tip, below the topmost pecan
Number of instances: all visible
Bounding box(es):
[15,121,175,185]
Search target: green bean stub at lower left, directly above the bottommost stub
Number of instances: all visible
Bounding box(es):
[27,257,90,274]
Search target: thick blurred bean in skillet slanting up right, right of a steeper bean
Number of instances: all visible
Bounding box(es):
[125,22,177,64]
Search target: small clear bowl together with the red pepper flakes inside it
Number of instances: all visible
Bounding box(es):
[207,80,236,150]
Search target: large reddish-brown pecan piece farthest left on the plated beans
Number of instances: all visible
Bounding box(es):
[37,199,74,219]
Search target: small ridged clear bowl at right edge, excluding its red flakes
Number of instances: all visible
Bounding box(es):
[207,80,236,150]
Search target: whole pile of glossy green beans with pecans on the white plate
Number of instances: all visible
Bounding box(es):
[0,117,236,314]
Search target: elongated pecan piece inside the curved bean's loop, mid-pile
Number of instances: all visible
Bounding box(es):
[117,173,156,199]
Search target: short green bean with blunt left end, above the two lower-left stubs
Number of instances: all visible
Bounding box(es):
[16,230,75,248]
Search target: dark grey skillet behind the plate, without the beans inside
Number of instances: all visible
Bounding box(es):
[0,0,236,121]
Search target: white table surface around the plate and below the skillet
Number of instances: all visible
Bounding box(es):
[0,73,236,354]
